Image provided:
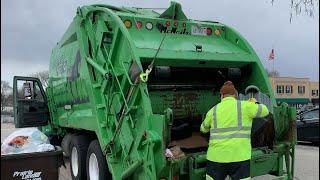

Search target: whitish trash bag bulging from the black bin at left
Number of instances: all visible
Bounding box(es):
[1,128,55,155]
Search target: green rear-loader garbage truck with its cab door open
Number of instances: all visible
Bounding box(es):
[14,2,296,180]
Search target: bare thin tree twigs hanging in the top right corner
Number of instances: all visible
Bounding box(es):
[271,0,319,23]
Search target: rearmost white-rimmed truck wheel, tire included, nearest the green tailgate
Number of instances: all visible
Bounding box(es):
[87,140,112,180]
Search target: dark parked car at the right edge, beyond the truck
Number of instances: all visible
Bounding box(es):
[297,108,319,144]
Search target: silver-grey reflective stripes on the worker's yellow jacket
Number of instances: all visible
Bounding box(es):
[210,101,252,140]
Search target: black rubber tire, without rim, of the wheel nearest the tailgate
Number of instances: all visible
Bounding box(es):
[86,140,112,180]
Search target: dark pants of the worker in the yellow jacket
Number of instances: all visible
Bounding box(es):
[207,160,250,180]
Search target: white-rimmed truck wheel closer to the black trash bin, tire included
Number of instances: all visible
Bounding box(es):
[69,135,90,180]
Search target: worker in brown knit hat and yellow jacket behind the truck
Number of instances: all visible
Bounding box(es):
[200,81,269,180]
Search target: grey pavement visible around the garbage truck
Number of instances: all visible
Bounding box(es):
[1,123,319,180]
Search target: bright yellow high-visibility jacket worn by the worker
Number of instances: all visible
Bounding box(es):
[200,97,269,163]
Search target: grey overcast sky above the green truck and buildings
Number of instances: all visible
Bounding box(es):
[1,0,319,84]
